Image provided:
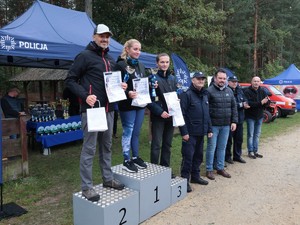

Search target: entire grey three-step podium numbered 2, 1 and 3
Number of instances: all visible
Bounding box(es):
[73,163,187,225]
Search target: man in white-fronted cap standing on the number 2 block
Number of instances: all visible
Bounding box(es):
[65,24,127,201]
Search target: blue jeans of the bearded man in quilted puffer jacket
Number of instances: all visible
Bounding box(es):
[206,126,230,171]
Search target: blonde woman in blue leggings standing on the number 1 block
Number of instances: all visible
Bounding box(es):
[116,39,147,173]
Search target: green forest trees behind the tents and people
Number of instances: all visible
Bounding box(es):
[0,0,300,89]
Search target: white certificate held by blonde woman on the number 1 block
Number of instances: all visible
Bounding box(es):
[131,77,151,107]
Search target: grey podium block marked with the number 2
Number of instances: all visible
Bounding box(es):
[73,184,139,225]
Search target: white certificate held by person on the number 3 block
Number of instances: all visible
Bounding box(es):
[164,91,185,127]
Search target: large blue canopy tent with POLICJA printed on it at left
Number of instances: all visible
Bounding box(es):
[0,0,156,69]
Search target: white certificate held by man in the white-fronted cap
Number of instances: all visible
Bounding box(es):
[103,71,126,102]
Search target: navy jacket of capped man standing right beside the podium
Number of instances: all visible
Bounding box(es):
[179,85,212,136]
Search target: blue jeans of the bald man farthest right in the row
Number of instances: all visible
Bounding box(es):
[246,118,263,153]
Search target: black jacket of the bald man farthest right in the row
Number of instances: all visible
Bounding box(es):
[244,86,267,120]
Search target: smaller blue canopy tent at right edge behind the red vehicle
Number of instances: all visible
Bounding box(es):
[264,64,300,110]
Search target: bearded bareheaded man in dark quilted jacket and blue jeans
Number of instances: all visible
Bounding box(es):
[206,69,238,180]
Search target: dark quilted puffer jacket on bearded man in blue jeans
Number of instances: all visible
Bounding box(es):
[207,84,238,126]
